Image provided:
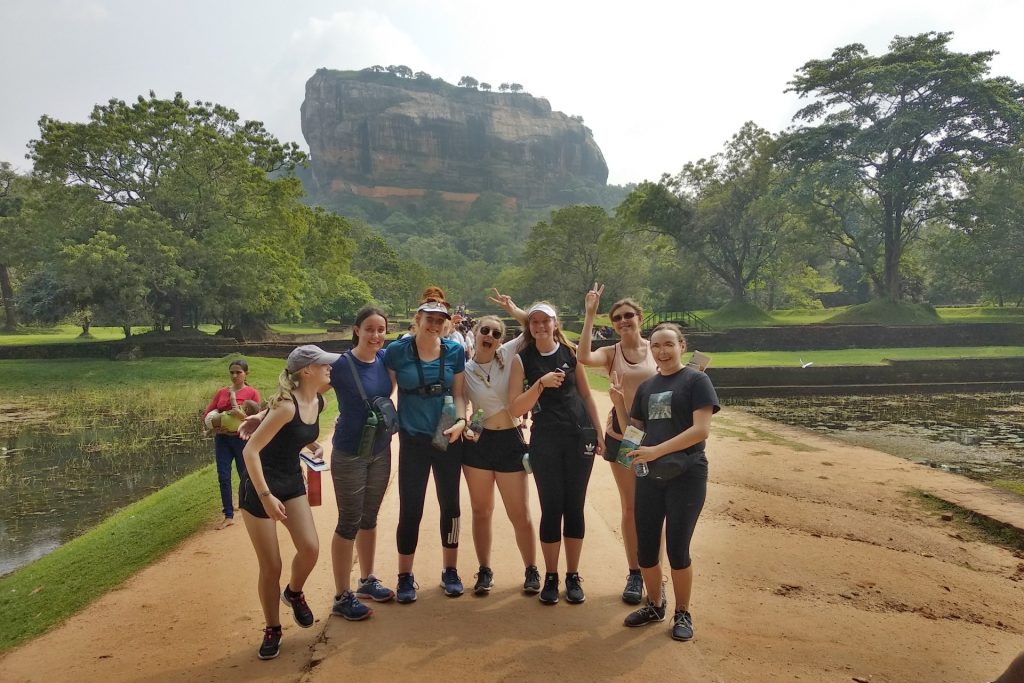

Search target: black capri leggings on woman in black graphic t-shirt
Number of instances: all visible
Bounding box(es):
[634,452,708,569]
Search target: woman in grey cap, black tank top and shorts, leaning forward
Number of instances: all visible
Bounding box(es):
[239,345,340,659]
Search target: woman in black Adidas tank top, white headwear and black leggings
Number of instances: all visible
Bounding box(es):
[509,301,604,604]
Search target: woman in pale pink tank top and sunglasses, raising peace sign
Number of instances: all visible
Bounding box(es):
[577,283,657,605]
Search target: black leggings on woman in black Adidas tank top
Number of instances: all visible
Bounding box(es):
[529,432,594,543]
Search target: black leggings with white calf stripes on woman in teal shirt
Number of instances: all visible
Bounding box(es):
[398,432,462,555]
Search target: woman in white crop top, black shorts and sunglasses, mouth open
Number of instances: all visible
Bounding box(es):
[462,289,541,595]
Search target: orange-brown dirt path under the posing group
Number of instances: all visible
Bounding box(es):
[0,397,1024,683]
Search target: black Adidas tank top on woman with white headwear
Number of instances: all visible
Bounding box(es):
[519,344,590,434]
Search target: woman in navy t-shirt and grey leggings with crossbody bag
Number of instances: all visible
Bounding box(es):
[331,307,397,622]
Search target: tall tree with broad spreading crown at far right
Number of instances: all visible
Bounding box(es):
[785,33,1024,301]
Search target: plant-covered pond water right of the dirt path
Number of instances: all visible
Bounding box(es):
[728,391,1024,481]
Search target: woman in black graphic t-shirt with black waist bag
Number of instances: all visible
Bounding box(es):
[609,323,719,641]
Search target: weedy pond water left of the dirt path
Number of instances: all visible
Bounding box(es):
[0,417,213,575]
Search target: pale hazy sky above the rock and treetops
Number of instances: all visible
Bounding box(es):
[6,0,1024,183]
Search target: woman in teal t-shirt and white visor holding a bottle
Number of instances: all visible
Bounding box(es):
[384,287,466,604]
